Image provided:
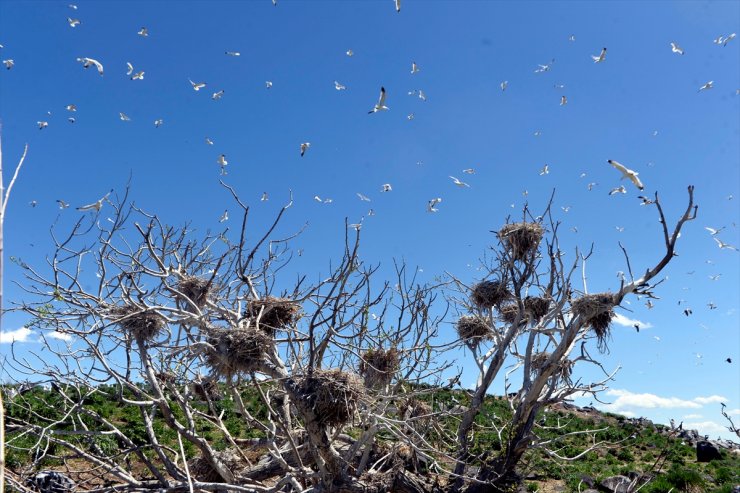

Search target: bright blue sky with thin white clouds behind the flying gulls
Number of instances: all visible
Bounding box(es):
[0,0,740,435]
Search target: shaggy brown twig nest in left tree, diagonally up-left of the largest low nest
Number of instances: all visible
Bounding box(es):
[205,328,274,378]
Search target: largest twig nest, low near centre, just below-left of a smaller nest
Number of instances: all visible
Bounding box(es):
[291,369,365,426]
